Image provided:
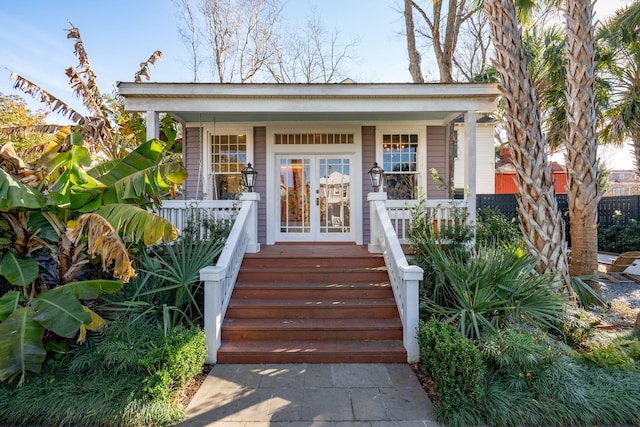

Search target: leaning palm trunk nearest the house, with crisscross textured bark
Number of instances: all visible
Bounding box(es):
[484,0,572,295]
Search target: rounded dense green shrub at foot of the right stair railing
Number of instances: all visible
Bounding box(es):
[418,320,485,425]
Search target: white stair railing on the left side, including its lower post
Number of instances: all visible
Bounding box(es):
[200,193,260,363]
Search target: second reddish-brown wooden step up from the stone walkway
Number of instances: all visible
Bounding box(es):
[222,318,402,341]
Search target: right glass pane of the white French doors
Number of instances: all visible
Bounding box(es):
[318,158,351,233]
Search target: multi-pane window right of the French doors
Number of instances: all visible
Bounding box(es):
[382,133,418,200]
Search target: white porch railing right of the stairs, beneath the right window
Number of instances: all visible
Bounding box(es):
[385,200,468,244]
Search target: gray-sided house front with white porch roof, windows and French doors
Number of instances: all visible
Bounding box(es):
[118,82,498,245]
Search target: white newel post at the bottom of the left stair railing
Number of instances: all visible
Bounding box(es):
[200,265,227,363]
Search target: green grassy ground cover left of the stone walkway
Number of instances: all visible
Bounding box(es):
[0,325,205,426]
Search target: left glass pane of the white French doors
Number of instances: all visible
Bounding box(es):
[280,159,311,233]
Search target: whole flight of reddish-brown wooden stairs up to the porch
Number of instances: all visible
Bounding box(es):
[217,244,407,363]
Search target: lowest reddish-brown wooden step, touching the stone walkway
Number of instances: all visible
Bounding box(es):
[218,340,407,364]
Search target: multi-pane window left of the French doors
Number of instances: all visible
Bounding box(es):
[211,134,247,200]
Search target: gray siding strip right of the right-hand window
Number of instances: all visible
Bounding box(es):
[425,126,449,199]
